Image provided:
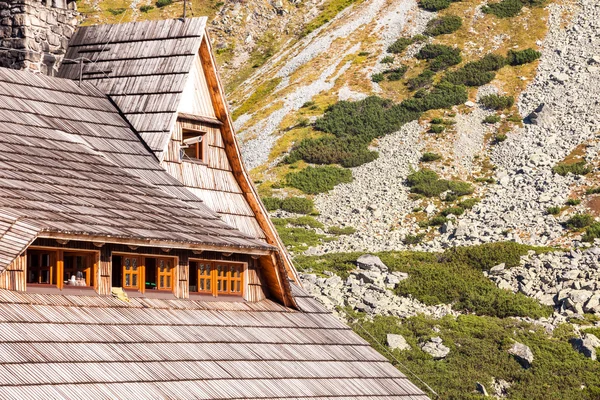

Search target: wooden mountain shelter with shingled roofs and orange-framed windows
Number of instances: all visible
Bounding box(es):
[0,18,427,400]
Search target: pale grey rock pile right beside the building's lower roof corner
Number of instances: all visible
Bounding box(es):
[300,254,458,318]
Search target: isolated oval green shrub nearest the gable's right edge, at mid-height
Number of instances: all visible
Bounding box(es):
[285,166,352,194]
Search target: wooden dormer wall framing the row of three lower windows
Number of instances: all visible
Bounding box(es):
[0,239,273,302]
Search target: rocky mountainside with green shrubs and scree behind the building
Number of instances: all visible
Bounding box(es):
[78,0,600,399]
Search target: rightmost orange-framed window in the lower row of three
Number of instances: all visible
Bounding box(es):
[190,261,244,296]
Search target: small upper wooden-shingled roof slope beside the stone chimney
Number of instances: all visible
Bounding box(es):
[59,17,206,158]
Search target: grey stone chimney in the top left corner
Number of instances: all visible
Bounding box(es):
[0,0,79,75]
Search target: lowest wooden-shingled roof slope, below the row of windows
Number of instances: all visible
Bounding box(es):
[0,290,428,400]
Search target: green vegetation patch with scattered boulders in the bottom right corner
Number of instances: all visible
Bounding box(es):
[350,315,600,400]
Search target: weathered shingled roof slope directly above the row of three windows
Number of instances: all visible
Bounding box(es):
[0,68,272,268]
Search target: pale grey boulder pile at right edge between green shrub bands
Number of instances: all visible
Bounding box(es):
[485,247,600,317]
